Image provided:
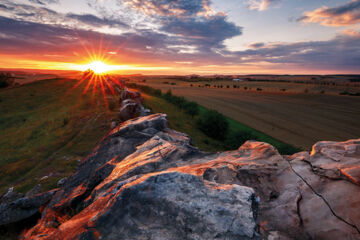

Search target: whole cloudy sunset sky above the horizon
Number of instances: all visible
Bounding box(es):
[0,0,360,74]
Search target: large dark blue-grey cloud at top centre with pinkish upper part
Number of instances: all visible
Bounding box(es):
[122,0,242,52]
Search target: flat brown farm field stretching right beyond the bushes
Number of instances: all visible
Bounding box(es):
[134,79,360,150]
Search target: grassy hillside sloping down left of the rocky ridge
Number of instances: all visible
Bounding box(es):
[0,79,115,193]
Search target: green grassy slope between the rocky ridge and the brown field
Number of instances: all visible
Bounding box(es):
[144,95,299,153]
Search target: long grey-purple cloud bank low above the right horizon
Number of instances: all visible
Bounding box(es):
[231,31,360,71]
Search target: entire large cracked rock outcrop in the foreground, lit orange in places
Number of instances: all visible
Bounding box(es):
[22,114,360,239]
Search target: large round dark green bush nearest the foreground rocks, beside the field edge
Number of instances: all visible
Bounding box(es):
[197,110,229,140]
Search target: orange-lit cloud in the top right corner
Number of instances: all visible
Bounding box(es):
[298,0,360,27]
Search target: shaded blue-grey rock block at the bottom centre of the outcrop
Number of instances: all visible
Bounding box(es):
[96,172,256,239]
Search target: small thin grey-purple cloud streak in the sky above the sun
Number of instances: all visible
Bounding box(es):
[66,13,129,28]
